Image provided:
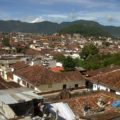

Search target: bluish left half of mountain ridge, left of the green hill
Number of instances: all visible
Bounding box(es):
[0,20,59,34]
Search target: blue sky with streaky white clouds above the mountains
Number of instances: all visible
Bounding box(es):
[0,0,120,26]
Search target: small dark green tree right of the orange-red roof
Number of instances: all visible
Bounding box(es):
[63,57,76,71]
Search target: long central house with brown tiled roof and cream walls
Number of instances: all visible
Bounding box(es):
[13,65,85,92]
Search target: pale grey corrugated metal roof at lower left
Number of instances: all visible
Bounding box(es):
[0,88,43,104]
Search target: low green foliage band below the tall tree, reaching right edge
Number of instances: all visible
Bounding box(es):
[79,53,120,70]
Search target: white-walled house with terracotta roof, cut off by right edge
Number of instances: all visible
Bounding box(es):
[86,67,120,95]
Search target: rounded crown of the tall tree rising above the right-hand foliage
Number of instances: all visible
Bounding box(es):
[80,44,99,59]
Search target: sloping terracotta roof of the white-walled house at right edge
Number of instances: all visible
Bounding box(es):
[89,69,120,90]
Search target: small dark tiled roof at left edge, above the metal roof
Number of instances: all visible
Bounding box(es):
[0,77,20,90]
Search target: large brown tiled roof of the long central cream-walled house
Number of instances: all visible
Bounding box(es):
[15,65,83,86]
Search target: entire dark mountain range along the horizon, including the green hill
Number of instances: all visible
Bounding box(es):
[0,20,120,37]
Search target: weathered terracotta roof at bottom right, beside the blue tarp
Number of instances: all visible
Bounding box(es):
[63,92,117,120]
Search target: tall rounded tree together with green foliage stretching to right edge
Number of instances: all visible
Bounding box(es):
[79,44,120,69]
